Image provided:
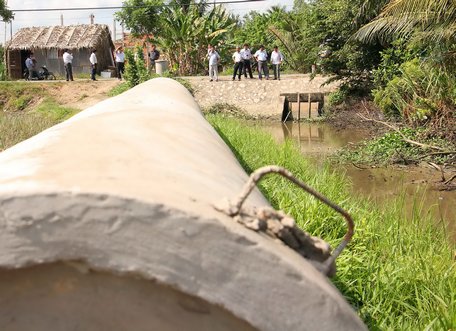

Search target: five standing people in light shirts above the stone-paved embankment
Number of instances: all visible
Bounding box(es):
[207,44,284,82]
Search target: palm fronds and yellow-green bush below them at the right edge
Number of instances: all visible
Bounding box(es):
[354,0,456,140]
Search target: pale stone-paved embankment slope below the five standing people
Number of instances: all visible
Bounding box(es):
[185,74,338,118]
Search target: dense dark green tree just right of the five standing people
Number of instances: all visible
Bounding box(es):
[271,0,386,89]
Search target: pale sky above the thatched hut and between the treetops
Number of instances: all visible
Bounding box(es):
[0,0,293,44]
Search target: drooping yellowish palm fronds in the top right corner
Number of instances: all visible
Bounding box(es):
[354,0,456,42]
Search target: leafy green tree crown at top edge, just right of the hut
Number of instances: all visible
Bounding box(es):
[115,0,164,36]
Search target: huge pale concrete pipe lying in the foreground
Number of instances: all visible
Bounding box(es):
[0,78,365,331]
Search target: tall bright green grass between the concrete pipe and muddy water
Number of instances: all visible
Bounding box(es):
[207,114,456,330]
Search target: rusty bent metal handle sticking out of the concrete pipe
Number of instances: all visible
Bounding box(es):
[230,166,355,269]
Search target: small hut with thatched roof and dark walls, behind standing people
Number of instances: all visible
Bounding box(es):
[6,24,114,78]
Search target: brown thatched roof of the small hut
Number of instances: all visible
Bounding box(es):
[7,24,113,49]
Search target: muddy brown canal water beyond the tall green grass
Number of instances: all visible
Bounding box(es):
[255,122,456,241]
